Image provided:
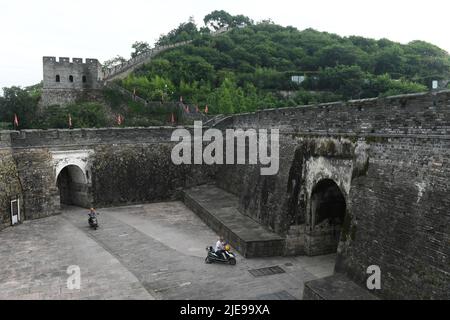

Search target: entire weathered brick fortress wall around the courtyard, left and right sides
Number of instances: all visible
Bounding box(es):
[0,91,450,299]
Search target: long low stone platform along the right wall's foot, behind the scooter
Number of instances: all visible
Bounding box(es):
[184,185,285,258]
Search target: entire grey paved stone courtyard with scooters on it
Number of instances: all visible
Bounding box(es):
[0,202,335,300]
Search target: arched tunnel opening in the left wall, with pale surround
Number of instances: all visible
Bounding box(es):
[56,165,91,208]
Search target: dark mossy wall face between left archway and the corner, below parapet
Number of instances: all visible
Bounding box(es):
[91,143,214,206]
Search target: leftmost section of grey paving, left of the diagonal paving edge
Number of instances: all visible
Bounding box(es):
[0,212,153,300]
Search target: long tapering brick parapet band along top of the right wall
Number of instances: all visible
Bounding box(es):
[219,91,450,135]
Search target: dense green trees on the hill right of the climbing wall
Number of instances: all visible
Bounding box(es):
[118,10,450,112]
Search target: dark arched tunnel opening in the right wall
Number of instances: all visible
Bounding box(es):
[309,179,347,255]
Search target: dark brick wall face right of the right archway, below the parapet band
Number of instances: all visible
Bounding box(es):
[336,137,450,299]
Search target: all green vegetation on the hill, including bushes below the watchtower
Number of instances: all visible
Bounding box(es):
[0,11,450,129]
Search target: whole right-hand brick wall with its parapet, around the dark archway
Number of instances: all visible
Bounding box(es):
[214,92,450,299]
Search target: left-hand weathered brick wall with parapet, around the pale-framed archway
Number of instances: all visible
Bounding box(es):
[5,127,215,219]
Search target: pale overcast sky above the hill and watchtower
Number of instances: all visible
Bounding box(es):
[0,0,450,88]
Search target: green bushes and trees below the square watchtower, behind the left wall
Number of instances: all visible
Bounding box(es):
[0,87,184,130]
